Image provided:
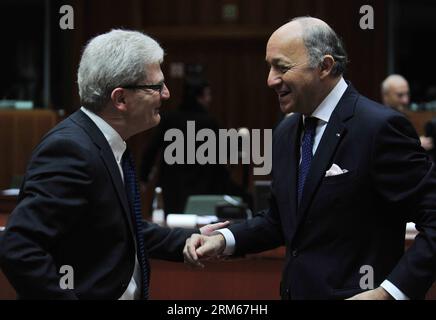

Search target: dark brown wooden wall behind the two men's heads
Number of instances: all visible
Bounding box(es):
[58,0,387,195]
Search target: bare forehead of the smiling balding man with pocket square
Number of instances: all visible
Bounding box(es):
[265,34,307,64]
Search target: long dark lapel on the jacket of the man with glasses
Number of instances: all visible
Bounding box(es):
[71,110,135,236]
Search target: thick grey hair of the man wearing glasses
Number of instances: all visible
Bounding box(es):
[77,29,164,112]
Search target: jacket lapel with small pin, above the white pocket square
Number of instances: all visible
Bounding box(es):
[297,84,358,226]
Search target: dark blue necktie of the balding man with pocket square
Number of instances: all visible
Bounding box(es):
[298,117,318,205]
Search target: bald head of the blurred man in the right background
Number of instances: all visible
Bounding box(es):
[381,74,410,113]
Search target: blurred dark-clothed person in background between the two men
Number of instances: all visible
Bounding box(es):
[141,66,244,214]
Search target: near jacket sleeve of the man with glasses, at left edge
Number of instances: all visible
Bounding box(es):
[0,138,92,299]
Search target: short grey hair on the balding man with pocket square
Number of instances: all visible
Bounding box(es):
[291,16,348,76]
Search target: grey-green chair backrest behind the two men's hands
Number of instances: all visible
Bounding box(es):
[184,195,242,216]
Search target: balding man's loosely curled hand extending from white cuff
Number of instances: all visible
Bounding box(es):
[183,234,226,268]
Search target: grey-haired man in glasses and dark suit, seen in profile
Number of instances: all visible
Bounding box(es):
[0,30,228,299]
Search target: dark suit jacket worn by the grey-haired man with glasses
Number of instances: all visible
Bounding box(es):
[0,111,194,299]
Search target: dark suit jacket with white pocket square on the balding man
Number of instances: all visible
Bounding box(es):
[230,85,436,299]
